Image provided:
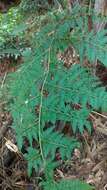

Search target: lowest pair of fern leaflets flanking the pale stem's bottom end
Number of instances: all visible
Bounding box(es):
[25,127,79,175]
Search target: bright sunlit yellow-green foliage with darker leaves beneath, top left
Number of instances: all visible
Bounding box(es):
[0,8,29,59]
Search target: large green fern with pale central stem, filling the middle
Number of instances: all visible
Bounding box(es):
[10,4,107,190]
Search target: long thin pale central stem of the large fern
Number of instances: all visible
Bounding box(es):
[39,48,50,165]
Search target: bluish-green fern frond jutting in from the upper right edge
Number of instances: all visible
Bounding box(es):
[74,24,107,66]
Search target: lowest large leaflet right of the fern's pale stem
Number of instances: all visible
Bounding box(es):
[41,127,79,160]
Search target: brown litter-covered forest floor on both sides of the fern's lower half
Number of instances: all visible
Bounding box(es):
[0,55,107,190]
